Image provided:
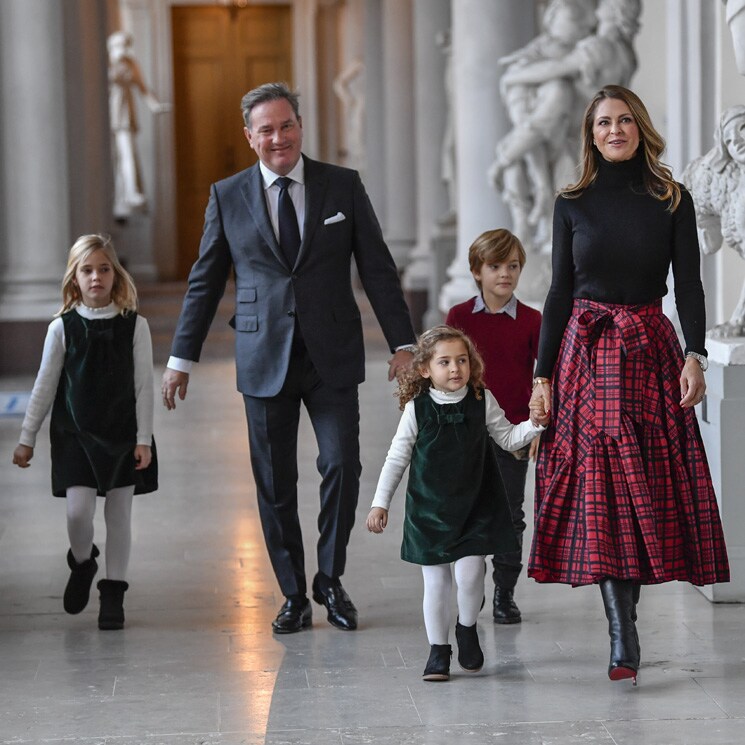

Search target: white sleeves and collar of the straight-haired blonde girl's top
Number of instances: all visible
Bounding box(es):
[18,303,154,447]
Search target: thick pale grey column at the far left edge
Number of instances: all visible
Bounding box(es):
[0,0,71,322]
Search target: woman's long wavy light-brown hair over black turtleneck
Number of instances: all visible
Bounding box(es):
[560,85,680,212]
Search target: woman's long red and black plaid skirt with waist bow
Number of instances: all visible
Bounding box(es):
[528,299,729,585]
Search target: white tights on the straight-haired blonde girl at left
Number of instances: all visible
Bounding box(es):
[66,486,135,580]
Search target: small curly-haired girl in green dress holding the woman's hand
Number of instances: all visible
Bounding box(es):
[367,326,543,681]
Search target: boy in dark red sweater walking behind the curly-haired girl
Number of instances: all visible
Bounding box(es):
[445,229,541,623]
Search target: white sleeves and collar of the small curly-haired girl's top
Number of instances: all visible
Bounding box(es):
[371,386,546,510]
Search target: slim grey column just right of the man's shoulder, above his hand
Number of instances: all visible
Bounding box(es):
[382,0,417,268]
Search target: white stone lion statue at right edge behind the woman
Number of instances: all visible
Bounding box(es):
[683,106,745,339]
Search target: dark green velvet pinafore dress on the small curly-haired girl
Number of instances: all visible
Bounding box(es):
[401,387,520,565]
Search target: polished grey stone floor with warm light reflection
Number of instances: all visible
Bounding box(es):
[0,286,745,745]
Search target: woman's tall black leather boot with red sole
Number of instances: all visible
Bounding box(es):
[600,578,640,685]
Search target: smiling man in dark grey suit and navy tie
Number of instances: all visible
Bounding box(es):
[163,83,414,633]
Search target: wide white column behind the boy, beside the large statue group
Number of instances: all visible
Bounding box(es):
[439,0,535,312]
